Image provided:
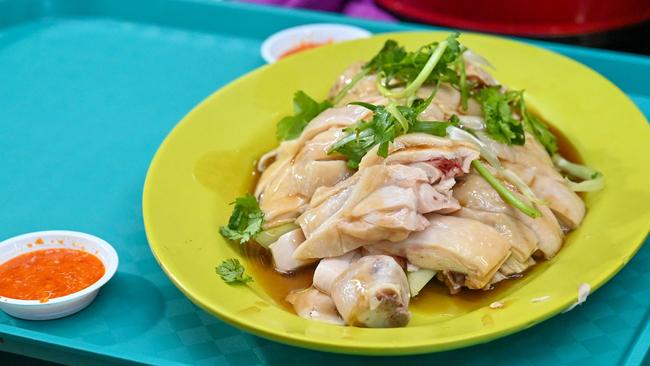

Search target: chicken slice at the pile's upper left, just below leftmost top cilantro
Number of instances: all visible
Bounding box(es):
[255,106,370,228]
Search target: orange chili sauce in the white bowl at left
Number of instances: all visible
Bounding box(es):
[0,249,105,302]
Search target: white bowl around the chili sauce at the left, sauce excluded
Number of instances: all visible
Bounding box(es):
[0,230,119,320]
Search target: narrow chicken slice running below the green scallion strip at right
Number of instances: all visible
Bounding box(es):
[454,173,564,258]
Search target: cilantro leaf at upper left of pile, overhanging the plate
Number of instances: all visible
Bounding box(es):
[275,90,332,141]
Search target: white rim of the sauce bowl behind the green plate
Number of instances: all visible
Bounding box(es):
[261,23,371,64]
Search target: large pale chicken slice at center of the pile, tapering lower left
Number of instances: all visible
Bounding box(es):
[294,165,433,259]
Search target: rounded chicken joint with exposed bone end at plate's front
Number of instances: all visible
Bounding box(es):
[332,255,411,328]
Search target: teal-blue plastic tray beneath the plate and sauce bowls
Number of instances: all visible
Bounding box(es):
[0,0,650,365]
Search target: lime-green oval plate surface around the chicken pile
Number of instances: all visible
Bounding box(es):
[143,32,650,355]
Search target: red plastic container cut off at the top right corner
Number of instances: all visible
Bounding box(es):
[375,0,650,37]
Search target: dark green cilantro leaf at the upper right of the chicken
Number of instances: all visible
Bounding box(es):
[474,86,526,145]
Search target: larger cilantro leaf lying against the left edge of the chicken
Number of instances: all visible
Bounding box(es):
[219,193,264,244]
